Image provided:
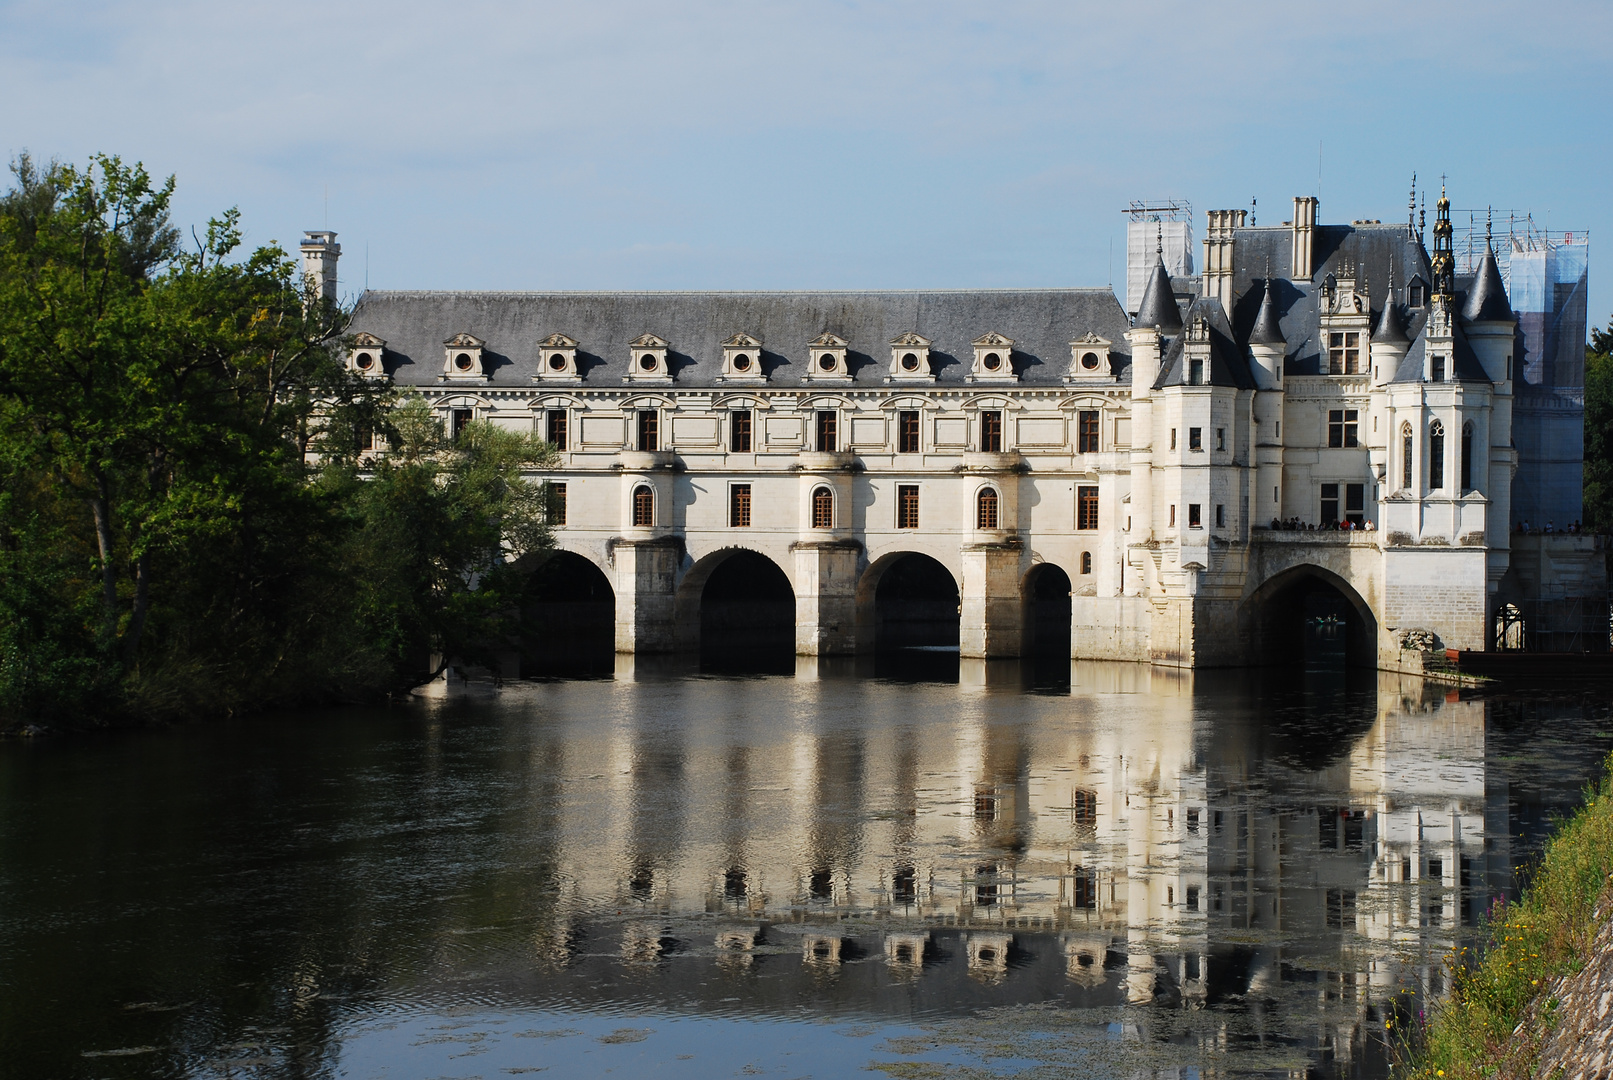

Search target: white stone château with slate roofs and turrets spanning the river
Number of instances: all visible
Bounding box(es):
[303,183,1605,667]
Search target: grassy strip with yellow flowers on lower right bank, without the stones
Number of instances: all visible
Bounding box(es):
[1397,754,1613,1080]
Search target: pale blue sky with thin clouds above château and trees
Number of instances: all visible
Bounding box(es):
[9,0,1613,326]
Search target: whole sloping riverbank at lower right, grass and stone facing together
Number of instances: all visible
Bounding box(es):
[1390,756,1613,1080]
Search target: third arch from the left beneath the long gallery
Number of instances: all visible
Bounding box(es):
[857,551,961,653]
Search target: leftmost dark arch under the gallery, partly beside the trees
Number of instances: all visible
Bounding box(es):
[521,551,616,675]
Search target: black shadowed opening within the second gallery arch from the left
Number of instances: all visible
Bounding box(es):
[700,550,795,674]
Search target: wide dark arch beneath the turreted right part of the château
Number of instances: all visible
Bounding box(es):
[1244,563,1378,667]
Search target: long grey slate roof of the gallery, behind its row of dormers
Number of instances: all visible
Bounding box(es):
[352,289,1131,388]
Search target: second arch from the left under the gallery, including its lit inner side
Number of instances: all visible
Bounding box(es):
[673,548,795,672]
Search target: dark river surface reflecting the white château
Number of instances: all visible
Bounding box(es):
[0,654,1613,1078]
